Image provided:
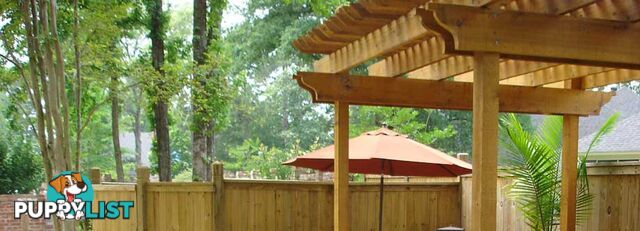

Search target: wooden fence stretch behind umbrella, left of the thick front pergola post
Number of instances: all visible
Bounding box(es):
[92,163,461,231]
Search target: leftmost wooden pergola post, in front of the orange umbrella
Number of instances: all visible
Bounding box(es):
[333,102,349,231]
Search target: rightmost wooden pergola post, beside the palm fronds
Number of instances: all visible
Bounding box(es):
[560,79,582,231]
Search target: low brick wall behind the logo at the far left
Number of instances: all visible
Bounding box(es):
[0,195,53,231]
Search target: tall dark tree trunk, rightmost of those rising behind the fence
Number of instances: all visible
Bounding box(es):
[191,0,209,181]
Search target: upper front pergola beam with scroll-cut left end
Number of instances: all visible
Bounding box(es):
[418,3,640,69]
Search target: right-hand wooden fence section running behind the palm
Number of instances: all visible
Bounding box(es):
[461,164,640,231]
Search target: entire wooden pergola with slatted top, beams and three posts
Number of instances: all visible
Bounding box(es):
[293,0,640,230]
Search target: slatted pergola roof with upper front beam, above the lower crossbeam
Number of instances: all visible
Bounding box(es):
[293,0,640,92]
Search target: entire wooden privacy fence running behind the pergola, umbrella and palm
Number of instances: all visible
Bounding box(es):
[92,164,640,231]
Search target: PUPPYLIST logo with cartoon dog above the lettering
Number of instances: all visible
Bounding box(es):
[14,171,133,220]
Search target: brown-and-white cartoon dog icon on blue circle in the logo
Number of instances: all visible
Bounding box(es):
[47,171,93,220]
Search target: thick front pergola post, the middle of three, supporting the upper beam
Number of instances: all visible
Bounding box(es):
[471,53,500,231]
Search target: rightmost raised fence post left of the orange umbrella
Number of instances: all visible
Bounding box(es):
[211,161,226,231]
